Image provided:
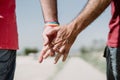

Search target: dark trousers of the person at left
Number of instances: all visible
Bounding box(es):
[0,50,16,80]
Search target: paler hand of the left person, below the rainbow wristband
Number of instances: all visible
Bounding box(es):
[39,26,59,63]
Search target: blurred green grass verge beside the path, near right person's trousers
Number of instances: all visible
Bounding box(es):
[80,52,106,73]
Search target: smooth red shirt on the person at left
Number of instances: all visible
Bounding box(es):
[0,0,18,50]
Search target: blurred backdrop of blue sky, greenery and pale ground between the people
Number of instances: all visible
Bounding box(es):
[15,0,111,80]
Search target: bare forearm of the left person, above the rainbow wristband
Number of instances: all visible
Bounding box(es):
[40,0,58,21]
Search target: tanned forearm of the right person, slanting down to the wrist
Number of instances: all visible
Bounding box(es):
[71,0,111,34]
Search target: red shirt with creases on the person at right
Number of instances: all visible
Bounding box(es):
[107,0,120,47]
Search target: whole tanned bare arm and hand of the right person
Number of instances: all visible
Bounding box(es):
[39,0,111,63]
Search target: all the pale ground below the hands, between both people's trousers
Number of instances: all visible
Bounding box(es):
[15,57,106,80]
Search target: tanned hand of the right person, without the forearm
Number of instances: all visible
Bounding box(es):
[53,25,77,64]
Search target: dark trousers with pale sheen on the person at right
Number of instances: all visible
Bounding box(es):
[105,47,120,80]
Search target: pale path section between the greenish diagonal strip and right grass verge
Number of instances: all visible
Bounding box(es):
[54,58,106,80]
